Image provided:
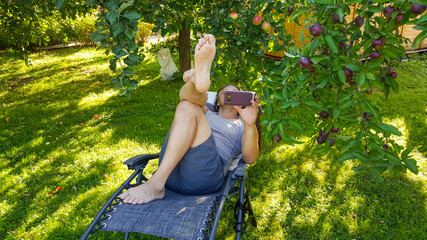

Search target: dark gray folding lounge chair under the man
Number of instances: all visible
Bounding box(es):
[81,93,256,239]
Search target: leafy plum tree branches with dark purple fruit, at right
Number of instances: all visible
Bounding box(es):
[211,0,427,177]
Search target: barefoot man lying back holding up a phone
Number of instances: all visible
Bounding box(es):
[120,35,260,204]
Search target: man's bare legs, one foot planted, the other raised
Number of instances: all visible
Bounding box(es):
[120,35,215,204]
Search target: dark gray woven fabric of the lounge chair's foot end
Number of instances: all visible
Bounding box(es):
[102,190,221,239]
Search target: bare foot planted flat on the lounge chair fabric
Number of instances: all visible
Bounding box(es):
[119,180,165,204]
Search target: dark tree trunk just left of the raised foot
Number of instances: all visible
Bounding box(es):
[178,21,191,73]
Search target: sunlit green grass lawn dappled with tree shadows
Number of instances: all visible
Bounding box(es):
[0,48,427,239]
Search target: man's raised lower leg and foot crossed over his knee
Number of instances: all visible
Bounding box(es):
[179,34,216,106]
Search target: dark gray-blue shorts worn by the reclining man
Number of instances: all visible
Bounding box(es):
[159,133,224,195]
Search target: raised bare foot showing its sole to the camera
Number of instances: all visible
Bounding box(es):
[194,34,216,92]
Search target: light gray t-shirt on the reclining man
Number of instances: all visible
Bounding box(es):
[205,110,243,165]
